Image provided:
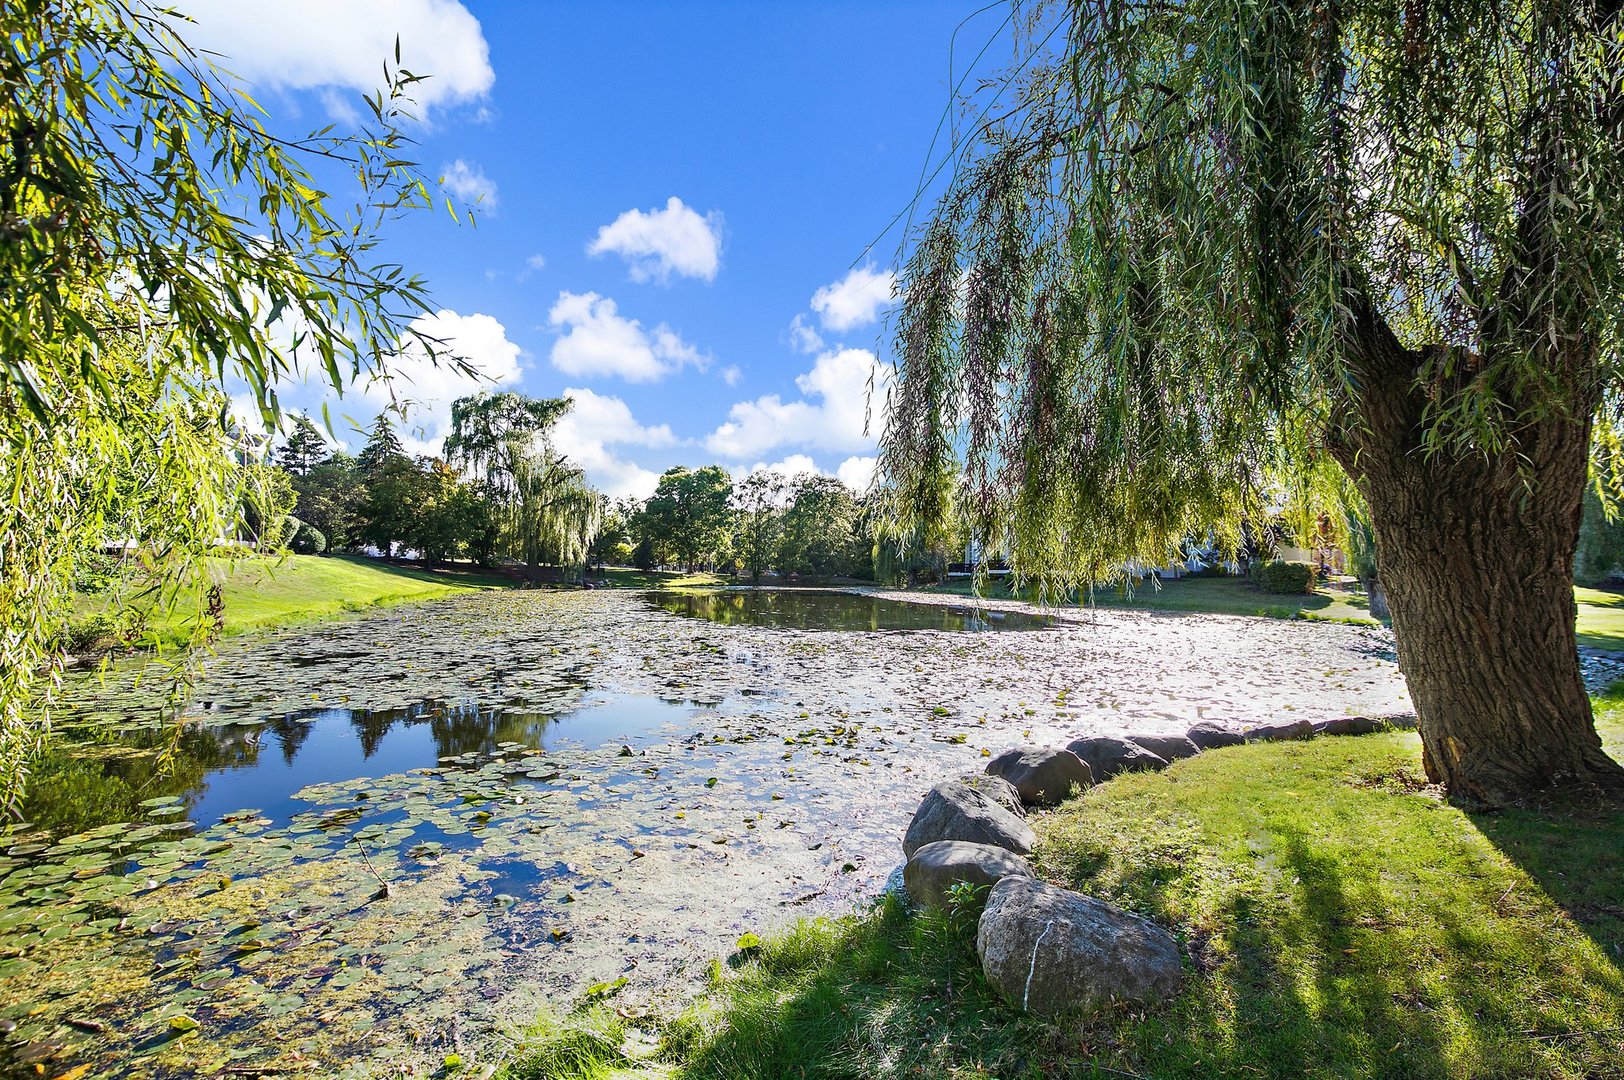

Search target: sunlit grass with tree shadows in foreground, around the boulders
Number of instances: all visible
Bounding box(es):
[508,695,1624,1080]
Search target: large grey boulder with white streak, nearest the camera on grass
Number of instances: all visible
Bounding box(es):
[976,877,1184,1017]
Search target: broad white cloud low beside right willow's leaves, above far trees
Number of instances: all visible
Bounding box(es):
[705,349,890,461]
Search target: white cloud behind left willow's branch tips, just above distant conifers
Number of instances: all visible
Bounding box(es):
[361,310,523,455]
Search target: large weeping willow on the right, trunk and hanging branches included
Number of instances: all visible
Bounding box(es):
[882,0,1624,804]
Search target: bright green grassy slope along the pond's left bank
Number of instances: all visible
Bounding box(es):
[78,555,513,643]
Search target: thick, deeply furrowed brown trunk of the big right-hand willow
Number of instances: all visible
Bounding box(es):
[1338,334,1624,806]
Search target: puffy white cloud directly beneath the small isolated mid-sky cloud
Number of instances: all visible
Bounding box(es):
[547,292,710,383]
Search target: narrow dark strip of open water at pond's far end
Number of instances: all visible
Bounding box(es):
[645,590,1054,630]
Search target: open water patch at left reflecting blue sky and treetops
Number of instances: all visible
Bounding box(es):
[24,693,702,833]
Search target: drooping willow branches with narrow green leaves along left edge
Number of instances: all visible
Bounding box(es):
[0,0,466,806]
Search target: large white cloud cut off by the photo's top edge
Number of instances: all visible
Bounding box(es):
[177,0,495,120]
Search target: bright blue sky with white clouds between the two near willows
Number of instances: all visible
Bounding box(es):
[185,0,1010,495]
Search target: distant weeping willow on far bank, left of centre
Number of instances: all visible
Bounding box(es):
[445,391,604,570]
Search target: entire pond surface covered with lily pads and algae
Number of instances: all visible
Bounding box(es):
[0,591,1406,1080]
